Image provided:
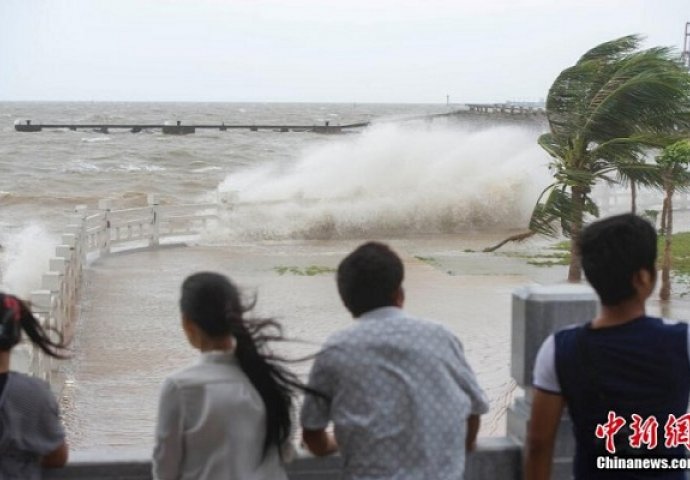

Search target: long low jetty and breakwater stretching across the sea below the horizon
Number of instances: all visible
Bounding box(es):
[14,103,545,135]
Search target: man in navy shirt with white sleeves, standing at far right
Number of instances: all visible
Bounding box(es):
[525,214,690,480]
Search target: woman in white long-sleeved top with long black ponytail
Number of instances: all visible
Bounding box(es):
[153,272,319,480]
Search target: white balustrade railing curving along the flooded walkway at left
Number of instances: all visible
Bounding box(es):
[18,195,218,381]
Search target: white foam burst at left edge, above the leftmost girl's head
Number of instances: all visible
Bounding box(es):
[0,224,57,298]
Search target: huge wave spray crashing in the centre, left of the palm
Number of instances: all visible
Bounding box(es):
[212,125,548,238]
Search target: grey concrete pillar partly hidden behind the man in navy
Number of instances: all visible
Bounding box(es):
[507,284,598,480]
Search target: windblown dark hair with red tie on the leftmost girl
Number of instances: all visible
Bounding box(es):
[0,292,67,359]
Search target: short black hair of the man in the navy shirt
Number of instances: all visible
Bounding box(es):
[578,213,657,306]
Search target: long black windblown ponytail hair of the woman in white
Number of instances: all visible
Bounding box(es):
[180,272,316,455]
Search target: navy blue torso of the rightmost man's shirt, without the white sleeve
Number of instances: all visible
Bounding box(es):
[554,316,690,480]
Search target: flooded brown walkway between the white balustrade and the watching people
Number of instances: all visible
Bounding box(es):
[63,240,551,451]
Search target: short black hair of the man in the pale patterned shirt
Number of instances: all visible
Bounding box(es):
[338,242,404,317]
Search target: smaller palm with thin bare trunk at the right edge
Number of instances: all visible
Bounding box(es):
[656,140,690,300]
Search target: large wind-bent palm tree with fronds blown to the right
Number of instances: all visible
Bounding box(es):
[529,35,690,281]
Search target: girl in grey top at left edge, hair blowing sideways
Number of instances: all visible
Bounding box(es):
[0,292,68,480]
